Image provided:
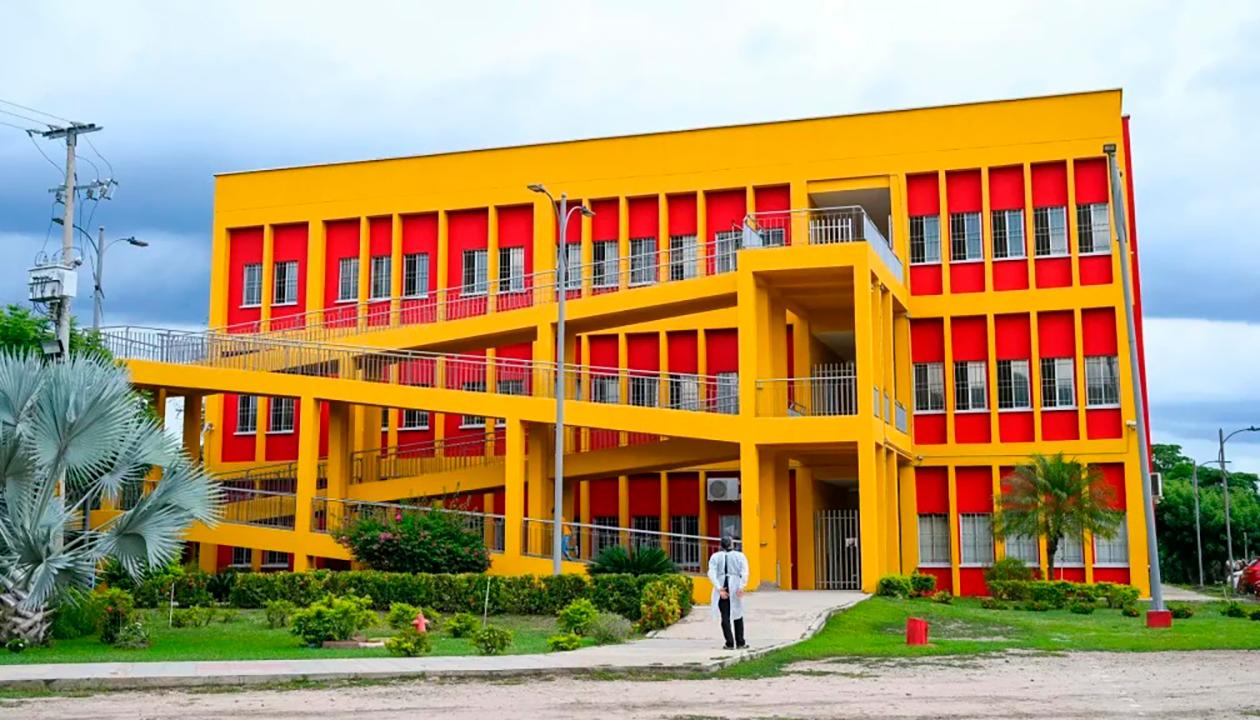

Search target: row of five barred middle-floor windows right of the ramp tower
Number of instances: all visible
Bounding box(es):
[914,356,1120,412]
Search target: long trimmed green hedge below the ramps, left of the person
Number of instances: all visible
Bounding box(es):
[216,570,692,620]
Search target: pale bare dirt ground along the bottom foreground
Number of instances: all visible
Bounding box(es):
[0,652,1260,720]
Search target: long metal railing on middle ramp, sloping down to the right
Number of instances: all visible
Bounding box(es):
[101,327,738,414]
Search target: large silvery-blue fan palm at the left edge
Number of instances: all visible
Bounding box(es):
[0,354,222,642]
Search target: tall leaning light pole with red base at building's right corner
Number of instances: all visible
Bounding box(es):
[1103,142,1172,617]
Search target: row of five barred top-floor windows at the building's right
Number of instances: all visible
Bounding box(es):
[910,203,1111,265]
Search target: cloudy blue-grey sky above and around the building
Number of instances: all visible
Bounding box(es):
[0,0,1260,470]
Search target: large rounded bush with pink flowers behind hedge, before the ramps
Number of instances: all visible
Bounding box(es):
[335,509,490,572]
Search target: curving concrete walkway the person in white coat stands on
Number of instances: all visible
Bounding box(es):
[0,590,866,690]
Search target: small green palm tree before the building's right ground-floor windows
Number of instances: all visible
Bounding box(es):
[993,453,1124,579]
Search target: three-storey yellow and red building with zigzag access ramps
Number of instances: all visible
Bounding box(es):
[107,91,1147,594]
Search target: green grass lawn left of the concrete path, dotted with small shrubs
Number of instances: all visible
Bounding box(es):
[0,610,577,665]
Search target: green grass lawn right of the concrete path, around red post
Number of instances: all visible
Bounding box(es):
[723,598,1260,677]
